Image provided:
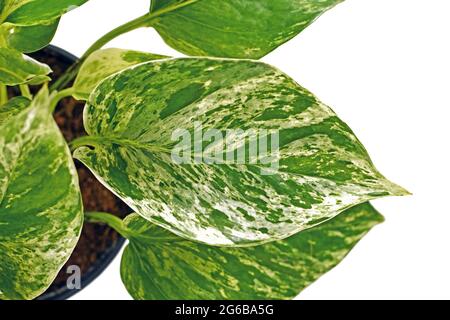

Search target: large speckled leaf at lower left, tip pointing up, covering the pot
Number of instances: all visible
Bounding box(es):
[0,89,83,300]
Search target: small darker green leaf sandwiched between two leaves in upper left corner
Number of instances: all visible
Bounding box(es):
[0,20,59,52]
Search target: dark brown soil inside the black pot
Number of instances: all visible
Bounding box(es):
[18,49,131,298]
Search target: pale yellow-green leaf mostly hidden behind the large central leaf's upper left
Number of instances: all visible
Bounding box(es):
[74,49,167,100]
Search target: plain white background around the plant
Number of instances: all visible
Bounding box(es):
[53,0,450,299]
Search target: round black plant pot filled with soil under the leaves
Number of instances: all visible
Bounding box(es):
[26,46,130,300]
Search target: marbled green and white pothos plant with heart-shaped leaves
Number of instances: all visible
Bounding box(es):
[0,0,407,299]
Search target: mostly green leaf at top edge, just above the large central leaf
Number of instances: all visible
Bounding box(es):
[147,0,343,58]
